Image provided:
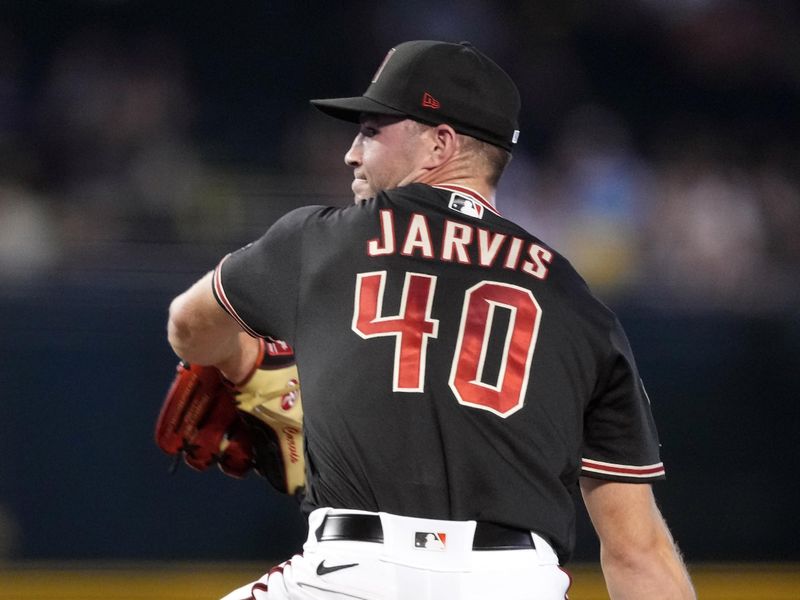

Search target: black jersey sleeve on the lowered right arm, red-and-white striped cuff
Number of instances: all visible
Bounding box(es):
[581,319,665,482]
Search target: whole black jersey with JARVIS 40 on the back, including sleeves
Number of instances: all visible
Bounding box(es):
[214,184,664,559]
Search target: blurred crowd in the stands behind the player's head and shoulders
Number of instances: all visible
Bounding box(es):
[0,0,800,313]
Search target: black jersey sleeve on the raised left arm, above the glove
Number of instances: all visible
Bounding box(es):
[213,207,322,344]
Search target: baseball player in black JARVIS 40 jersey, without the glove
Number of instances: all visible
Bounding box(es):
[164,41,694,600]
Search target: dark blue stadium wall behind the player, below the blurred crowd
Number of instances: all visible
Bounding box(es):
[0,284,800,560]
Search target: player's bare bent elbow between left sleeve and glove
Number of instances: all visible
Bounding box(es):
[167,272,259,382]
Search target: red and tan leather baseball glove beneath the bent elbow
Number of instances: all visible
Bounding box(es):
[155,340,305,495]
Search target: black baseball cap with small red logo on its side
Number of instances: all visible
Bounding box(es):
[311,40,520,151]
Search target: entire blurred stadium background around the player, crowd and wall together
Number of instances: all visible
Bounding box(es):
[0,0,800,600]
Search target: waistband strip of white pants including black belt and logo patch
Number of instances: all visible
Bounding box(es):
[316,510,555,557]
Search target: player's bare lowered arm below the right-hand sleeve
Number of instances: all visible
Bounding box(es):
[580,477,696,600]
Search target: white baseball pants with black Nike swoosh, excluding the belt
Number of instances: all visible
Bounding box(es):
[222,508,570,600]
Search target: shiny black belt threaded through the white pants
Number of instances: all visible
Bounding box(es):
[317,514,536,550]
